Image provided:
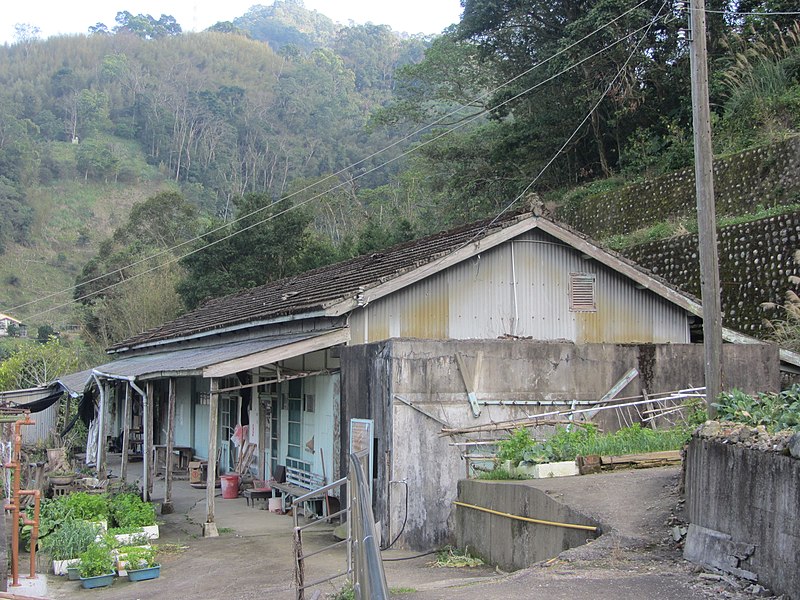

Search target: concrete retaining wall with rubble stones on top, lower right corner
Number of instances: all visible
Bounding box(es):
[684,423,800,598]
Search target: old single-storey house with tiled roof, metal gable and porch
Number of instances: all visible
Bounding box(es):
[81,213,798,547]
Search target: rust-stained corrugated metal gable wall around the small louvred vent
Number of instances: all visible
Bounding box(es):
[350,231,689,344]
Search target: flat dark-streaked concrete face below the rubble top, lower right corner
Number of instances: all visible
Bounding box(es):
[685,438,800,598]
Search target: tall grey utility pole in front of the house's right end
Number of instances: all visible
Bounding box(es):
[689,0,722,418]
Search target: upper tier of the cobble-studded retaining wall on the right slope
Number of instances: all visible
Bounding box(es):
[557,137,800,238]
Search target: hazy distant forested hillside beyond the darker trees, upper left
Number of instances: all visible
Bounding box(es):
[0,0,427,342]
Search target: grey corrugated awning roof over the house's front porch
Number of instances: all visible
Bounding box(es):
[94,331,328,378]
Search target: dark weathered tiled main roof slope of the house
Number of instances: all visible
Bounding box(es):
[109,213,531,351]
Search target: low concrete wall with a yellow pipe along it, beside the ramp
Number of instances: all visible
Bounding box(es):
[455,480,598,571]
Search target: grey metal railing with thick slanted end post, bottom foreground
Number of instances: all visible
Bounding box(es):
[292,453,389,600]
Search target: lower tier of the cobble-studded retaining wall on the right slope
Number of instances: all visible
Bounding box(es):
[624,212,800,336]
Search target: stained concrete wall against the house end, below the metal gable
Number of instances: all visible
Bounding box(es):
[341,340,779,549]
